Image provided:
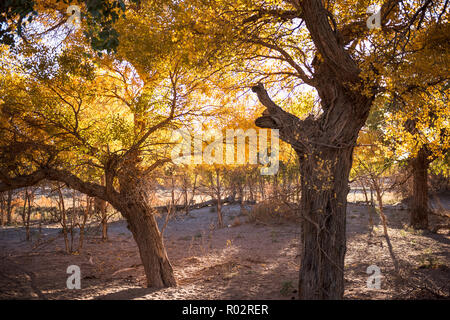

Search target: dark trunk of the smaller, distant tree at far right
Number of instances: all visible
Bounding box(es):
[410,148,429,229]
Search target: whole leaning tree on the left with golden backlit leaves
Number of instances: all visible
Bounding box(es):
[0,21,210,287]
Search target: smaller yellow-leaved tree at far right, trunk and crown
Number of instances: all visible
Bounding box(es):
[383,19,450,229]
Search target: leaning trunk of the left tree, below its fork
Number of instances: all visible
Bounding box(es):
[120,197,176,288]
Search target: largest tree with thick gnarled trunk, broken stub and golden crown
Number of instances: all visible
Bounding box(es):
[168,0,447,299]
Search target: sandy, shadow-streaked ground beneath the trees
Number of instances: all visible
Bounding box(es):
[0,199,450,299]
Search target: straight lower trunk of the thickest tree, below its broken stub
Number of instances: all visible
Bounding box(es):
[299,147,353,299]
